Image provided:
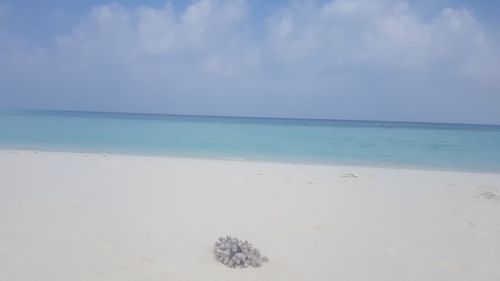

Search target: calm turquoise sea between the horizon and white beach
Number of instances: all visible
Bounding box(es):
[0,111,500,172]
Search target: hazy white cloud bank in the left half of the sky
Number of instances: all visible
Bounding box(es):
[57,0,252,73]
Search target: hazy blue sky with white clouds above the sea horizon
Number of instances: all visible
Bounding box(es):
[0,0,500,124]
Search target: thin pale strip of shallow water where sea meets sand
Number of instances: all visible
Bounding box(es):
[0,148,500,175]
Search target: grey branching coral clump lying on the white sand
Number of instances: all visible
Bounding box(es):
[214,236,268,268]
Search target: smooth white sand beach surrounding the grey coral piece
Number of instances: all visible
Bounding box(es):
[0,150,500,281]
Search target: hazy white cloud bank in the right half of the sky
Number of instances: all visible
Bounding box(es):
[269,0,500,80]
